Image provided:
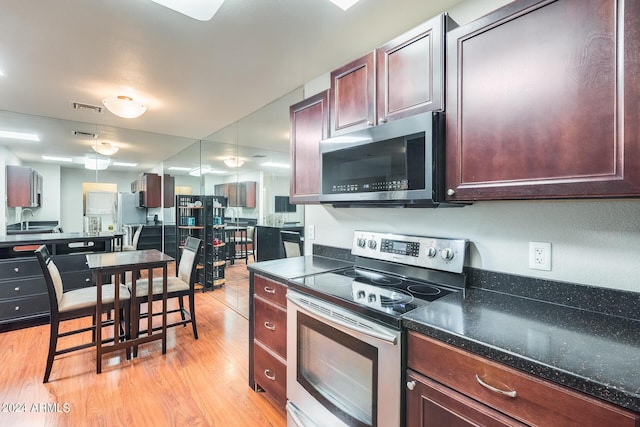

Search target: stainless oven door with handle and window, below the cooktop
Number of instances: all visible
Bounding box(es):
[287,290,401,427]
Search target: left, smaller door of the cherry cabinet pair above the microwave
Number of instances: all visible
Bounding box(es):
[329,52,376,136]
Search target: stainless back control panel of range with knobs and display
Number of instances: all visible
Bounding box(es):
[351,231,469,273]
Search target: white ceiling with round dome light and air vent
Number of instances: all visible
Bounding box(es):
[0,0,460,169]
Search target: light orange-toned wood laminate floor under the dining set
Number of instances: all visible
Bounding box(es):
[0,286,286,427]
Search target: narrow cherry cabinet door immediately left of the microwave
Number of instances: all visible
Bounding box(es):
[289,91,329,203]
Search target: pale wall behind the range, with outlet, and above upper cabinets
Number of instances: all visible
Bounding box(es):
[304,0,640,292]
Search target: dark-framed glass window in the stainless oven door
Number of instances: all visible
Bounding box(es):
[297,312,378,426]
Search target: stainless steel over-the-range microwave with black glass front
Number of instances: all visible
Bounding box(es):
[320,111,445,207]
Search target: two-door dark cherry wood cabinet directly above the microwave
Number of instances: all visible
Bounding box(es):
[330,14,456,136]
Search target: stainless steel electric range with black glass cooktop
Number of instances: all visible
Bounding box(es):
[287,231,468,427]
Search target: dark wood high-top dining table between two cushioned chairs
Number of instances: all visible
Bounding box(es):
[86,249,174,373]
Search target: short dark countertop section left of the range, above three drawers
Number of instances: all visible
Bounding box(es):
[247,255,353,280]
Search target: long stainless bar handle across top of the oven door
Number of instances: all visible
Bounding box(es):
[287,292,399,345]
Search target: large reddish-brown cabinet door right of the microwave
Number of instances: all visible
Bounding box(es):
[447,0,640,200]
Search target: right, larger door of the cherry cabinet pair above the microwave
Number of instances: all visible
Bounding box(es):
[376,14,453,124]
